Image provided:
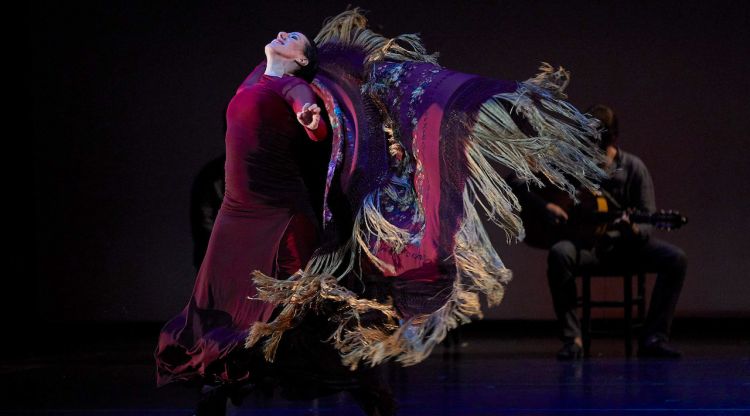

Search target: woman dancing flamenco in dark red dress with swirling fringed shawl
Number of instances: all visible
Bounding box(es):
[155,9,605,415]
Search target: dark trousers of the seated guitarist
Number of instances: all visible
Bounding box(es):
[547,238,687,343]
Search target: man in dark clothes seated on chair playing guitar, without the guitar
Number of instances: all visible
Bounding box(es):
[511,105,687,360]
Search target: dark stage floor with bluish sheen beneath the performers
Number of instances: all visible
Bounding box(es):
[0,327,750,416]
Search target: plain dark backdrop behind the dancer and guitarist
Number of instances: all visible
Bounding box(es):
[30,1,750,323]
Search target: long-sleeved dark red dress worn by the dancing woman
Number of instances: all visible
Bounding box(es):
[154,75,327,386]
